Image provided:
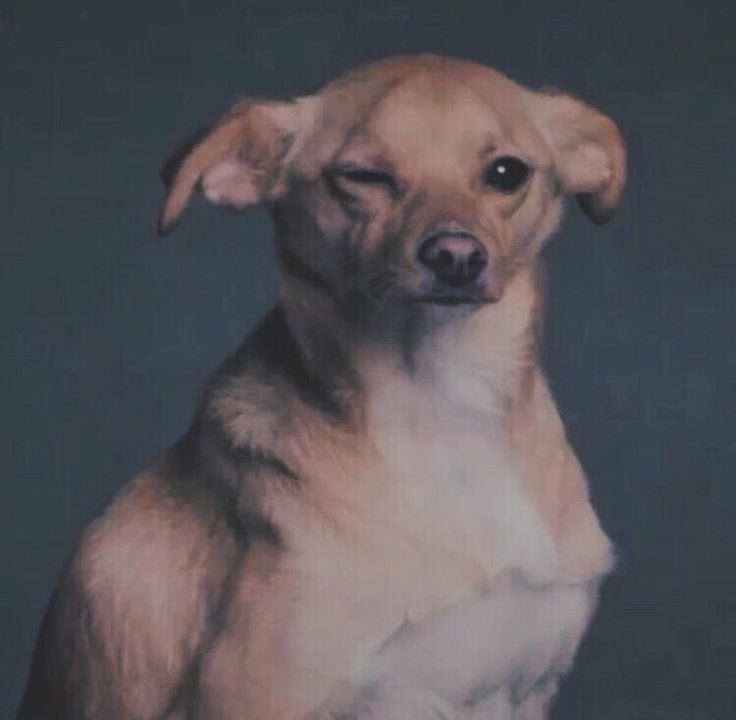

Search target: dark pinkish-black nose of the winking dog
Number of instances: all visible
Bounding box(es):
[419,233,488,287]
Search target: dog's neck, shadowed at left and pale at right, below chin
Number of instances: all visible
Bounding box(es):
[282,268,538,419]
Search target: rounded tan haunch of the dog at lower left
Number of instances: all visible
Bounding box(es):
[20,457,241,718]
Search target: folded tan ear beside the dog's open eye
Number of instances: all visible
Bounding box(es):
[532,90,626,224]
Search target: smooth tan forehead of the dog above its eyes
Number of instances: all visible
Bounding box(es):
[314,56,538,162]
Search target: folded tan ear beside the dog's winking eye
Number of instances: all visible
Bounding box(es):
[158,96,319,235]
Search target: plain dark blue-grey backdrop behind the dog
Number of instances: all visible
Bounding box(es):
[0,0,736,720]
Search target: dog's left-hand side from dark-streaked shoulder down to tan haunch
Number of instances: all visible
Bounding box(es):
[19,312,320,718]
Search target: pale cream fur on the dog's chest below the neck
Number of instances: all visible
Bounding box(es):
[274,286,608,717]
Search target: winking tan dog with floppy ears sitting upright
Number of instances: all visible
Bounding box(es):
[19,55,626,720]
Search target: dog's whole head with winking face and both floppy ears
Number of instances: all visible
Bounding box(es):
[162,56,625,324]
